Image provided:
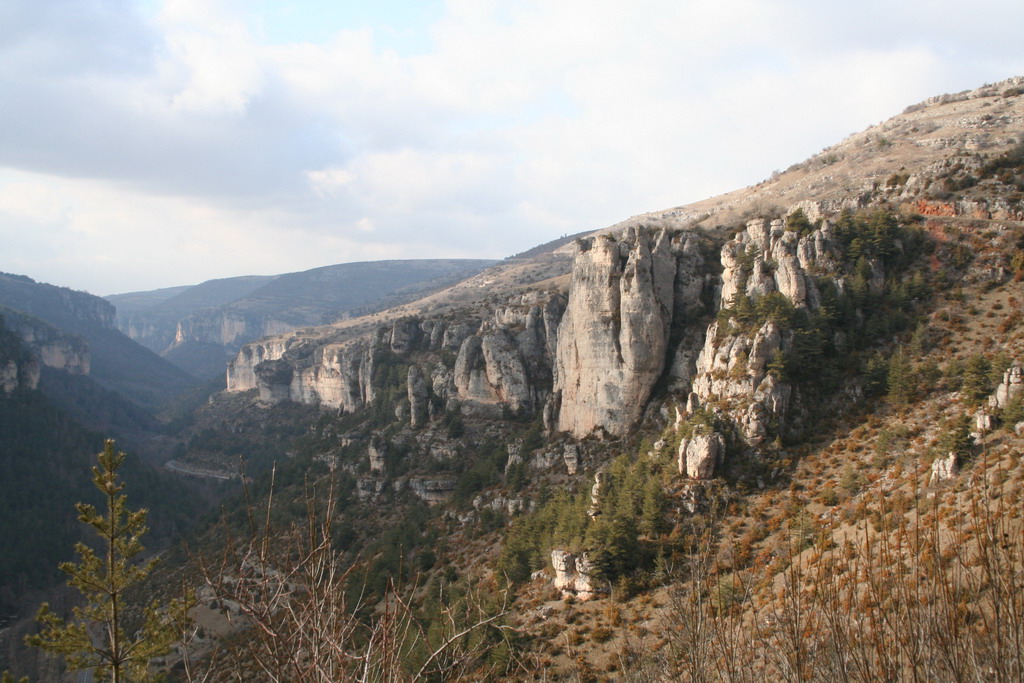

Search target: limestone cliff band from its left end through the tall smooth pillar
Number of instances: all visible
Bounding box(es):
[228,228,708,436]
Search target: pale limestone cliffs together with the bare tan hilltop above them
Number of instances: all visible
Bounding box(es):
[222,76,1022,458]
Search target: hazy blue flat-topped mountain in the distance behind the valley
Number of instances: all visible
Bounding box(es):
[106,259,495,378]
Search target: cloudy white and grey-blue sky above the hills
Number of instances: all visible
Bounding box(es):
[0,0,1024,295]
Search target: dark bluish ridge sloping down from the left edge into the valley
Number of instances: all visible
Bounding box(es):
[0,273,198,412]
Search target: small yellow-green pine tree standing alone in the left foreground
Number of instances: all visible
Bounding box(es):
[26,439,188,683]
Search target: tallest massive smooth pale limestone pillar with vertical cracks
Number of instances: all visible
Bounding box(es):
[555,229,677,437]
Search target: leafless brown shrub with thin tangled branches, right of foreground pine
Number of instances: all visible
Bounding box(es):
[191,471,517,683]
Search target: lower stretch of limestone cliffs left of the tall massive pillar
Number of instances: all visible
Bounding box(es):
[227,301,561,427]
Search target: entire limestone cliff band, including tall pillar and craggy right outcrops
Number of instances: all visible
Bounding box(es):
[228,210,856,444]
